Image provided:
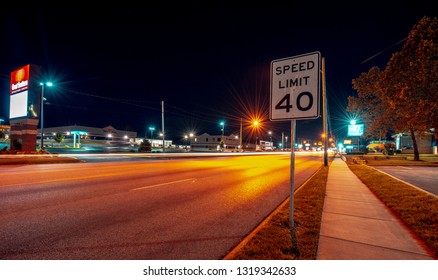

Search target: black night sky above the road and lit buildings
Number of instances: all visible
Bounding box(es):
[0,1,436,144]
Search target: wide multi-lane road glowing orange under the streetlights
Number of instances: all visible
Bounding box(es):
[0,154,323,260]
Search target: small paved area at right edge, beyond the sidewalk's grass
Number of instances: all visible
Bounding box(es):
[373,166,438,195]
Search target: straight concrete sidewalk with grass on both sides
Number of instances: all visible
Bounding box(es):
[316,158,434,260]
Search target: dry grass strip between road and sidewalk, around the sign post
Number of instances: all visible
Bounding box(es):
[229,163,328,260]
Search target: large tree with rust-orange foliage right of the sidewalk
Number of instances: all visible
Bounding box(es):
[347,17,438,160]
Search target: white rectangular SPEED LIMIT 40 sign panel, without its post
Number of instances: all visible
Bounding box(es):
[269,52,321,121]
